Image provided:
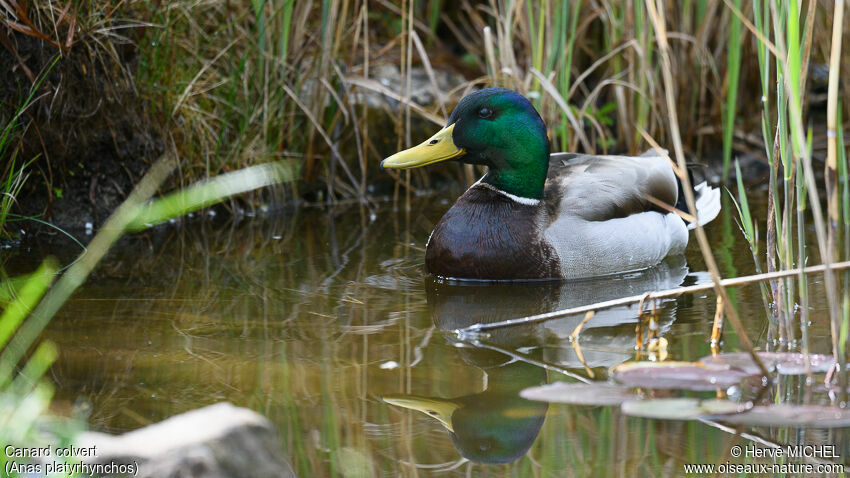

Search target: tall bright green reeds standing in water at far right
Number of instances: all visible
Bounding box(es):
[724,1,850,383]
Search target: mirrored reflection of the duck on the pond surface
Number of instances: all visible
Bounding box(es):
[384,258,693,463]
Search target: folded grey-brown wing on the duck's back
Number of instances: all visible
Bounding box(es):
[545,152,678,221]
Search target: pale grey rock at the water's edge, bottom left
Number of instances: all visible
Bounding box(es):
[77,403,295,478]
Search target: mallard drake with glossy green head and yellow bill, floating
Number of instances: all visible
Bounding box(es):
[381,88,720,281]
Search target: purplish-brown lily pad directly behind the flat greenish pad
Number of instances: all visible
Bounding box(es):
[611,362,753,391]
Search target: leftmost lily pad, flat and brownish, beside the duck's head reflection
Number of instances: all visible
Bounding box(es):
[519,382,636,405]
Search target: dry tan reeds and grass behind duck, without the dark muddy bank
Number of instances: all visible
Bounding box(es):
[0,0,840,205]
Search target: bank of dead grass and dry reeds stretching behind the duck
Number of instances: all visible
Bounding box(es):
[0,0,850,212]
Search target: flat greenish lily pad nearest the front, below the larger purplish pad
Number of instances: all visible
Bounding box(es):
[622,398,750,420]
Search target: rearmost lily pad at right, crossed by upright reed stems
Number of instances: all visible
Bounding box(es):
[699,352,835,375]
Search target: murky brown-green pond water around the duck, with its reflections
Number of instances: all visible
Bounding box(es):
[5,190,850,476]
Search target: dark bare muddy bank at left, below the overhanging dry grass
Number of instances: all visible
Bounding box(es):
[0,25,164,230]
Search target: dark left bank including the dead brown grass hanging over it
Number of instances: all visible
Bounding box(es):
[0,0,163,230]
